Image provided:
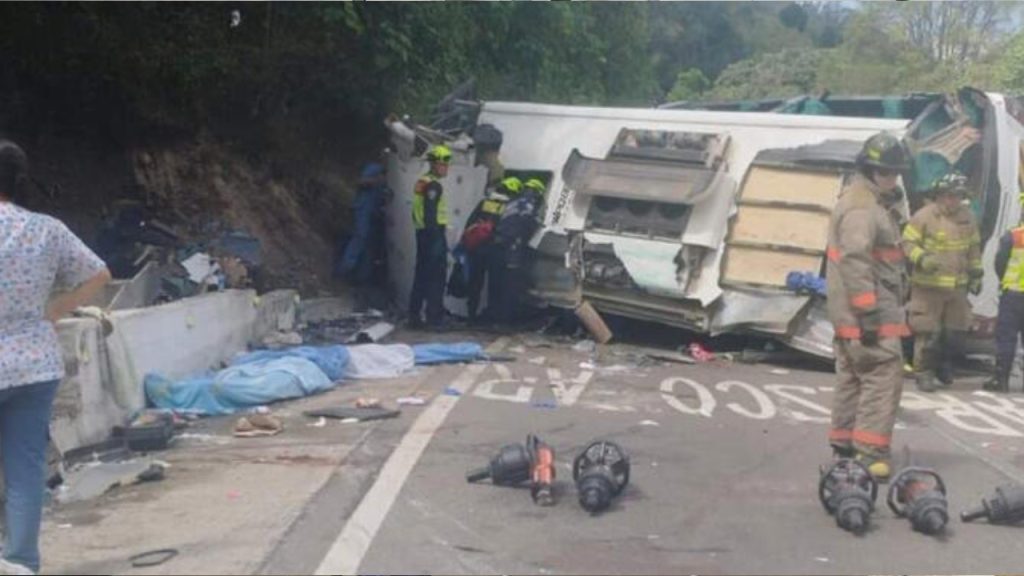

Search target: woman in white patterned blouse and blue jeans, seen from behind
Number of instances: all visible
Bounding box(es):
[0,139,111,574]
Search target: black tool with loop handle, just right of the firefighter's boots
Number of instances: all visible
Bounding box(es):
[886,466,949,534]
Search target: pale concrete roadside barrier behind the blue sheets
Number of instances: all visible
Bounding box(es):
[51,290,297,452]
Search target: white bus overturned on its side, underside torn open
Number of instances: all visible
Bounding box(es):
[387,88,1024,358]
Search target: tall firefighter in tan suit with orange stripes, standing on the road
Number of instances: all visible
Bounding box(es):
[826,132,909,482]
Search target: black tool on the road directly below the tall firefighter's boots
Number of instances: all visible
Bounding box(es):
[818,458,879,535]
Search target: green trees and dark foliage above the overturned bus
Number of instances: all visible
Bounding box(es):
[0,1,1024,152]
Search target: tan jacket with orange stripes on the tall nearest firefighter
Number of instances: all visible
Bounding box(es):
[825,174,910,340]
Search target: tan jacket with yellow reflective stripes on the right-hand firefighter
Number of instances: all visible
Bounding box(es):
[903,203,981,290]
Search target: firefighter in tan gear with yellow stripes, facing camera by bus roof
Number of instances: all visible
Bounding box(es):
[903,172,982,393]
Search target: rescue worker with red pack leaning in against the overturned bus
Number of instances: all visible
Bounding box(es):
[462,176,522,321]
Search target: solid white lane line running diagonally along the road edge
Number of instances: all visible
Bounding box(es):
[316,338,508,575]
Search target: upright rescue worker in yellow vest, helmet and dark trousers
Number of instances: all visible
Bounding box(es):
[409,145,452,328]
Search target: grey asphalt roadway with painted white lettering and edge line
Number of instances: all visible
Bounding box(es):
[267,330,1024,574]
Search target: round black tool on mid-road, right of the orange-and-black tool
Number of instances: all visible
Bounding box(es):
[572,441,630,515]
